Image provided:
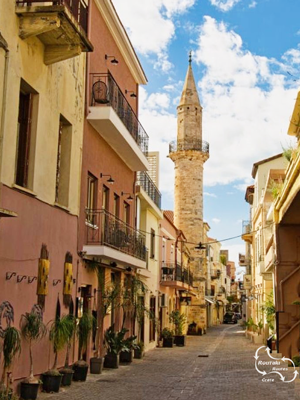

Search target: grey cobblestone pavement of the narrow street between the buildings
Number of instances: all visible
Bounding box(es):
[39,325,300,400]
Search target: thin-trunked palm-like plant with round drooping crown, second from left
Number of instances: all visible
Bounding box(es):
[20,310,47,383]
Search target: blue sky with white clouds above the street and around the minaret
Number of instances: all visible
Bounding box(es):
[113,0,300,274]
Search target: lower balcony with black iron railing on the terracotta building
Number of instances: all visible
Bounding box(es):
[83,210,146,268]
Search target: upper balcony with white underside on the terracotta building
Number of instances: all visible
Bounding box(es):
[87,73,149,171]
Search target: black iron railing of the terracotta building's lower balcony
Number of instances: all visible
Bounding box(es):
[86,210,146,261]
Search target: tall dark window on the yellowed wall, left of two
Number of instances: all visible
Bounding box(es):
[16,80,38,188]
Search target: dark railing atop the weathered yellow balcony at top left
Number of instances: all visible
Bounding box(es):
[16,0,89,32]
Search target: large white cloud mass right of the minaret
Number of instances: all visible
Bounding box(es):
[194,17,297,190]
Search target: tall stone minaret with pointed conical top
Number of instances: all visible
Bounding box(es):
[169,53,209,326]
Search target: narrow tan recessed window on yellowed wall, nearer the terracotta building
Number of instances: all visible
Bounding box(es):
[55,115,72,207]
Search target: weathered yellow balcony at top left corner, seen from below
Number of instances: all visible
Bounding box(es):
[16,0,93,65]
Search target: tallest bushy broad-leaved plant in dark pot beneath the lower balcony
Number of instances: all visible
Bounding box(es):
[104,325,129,368]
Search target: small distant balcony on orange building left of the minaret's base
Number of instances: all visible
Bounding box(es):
[160,263,193,290]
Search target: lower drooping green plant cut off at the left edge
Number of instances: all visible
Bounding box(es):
[1,326,21,386]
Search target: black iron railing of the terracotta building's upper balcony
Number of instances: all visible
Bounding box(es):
[91,73,149,156]
